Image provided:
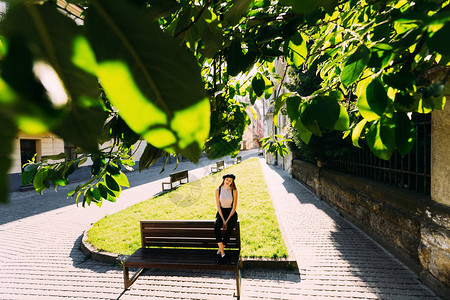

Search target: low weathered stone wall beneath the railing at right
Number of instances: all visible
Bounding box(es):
[292,160,450,289]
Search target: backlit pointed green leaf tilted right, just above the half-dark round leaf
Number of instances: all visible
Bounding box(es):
[341,45,370,87]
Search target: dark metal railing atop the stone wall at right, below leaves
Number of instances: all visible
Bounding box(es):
[326,114,431,195]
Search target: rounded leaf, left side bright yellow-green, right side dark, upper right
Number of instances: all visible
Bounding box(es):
[358,79,389,121]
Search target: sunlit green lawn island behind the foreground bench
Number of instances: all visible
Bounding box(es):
[88,158,287,258]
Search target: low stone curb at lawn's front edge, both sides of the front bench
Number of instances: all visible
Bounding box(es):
[80,230,298,270]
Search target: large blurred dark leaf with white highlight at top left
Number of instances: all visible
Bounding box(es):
[3,2,103,152]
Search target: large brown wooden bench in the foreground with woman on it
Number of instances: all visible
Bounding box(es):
[123,221,242,298]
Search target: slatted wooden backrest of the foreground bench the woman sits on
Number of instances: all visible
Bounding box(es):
[141,220,241,250]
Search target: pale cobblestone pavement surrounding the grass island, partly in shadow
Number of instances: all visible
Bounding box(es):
[0,152,437,299]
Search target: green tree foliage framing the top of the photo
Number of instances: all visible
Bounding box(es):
[0,0,450,203]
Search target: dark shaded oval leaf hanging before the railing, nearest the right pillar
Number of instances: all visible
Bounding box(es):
[395,111,416,155]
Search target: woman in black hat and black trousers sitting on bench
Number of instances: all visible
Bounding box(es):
[214,174,238,264]
